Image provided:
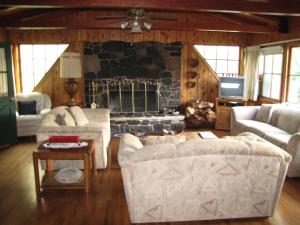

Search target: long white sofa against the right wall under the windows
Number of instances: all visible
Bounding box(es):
[231,104,300,177]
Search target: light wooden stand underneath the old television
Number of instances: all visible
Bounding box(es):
[216,98,248,130]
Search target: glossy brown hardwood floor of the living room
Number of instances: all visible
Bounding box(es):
[0,132,300,225]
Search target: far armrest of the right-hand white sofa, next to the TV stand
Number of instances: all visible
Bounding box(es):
[231,106,260,121]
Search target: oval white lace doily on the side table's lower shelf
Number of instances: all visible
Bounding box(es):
[54,168,83,184]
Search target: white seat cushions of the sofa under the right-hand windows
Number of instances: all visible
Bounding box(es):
[238,120,287,137]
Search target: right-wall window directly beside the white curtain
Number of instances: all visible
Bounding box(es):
[259,47,283,100]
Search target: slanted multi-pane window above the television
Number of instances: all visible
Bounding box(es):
[195,45,240,76]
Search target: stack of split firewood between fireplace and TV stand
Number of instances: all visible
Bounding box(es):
[185,100,216,128]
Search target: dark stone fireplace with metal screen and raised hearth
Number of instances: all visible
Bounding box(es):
[84,41,183,132]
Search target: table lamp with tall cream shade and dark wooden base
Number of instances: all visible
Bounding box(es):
[60,52,82,106]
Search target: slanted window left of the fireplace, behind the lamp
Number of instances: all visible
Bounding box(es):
[20,44,68,93]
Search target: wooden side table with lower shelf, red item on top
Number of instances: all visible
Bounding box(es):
[32,140,96,196]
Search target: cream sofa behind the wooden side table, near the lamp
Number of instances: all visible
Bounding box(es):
[37,106,110,169]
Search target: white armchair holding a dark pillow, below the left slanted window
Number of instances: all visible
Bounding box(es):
[15,92,51,137]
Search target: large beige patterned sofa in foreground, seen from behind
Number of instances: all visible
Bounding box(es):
[118,134,291,223]
